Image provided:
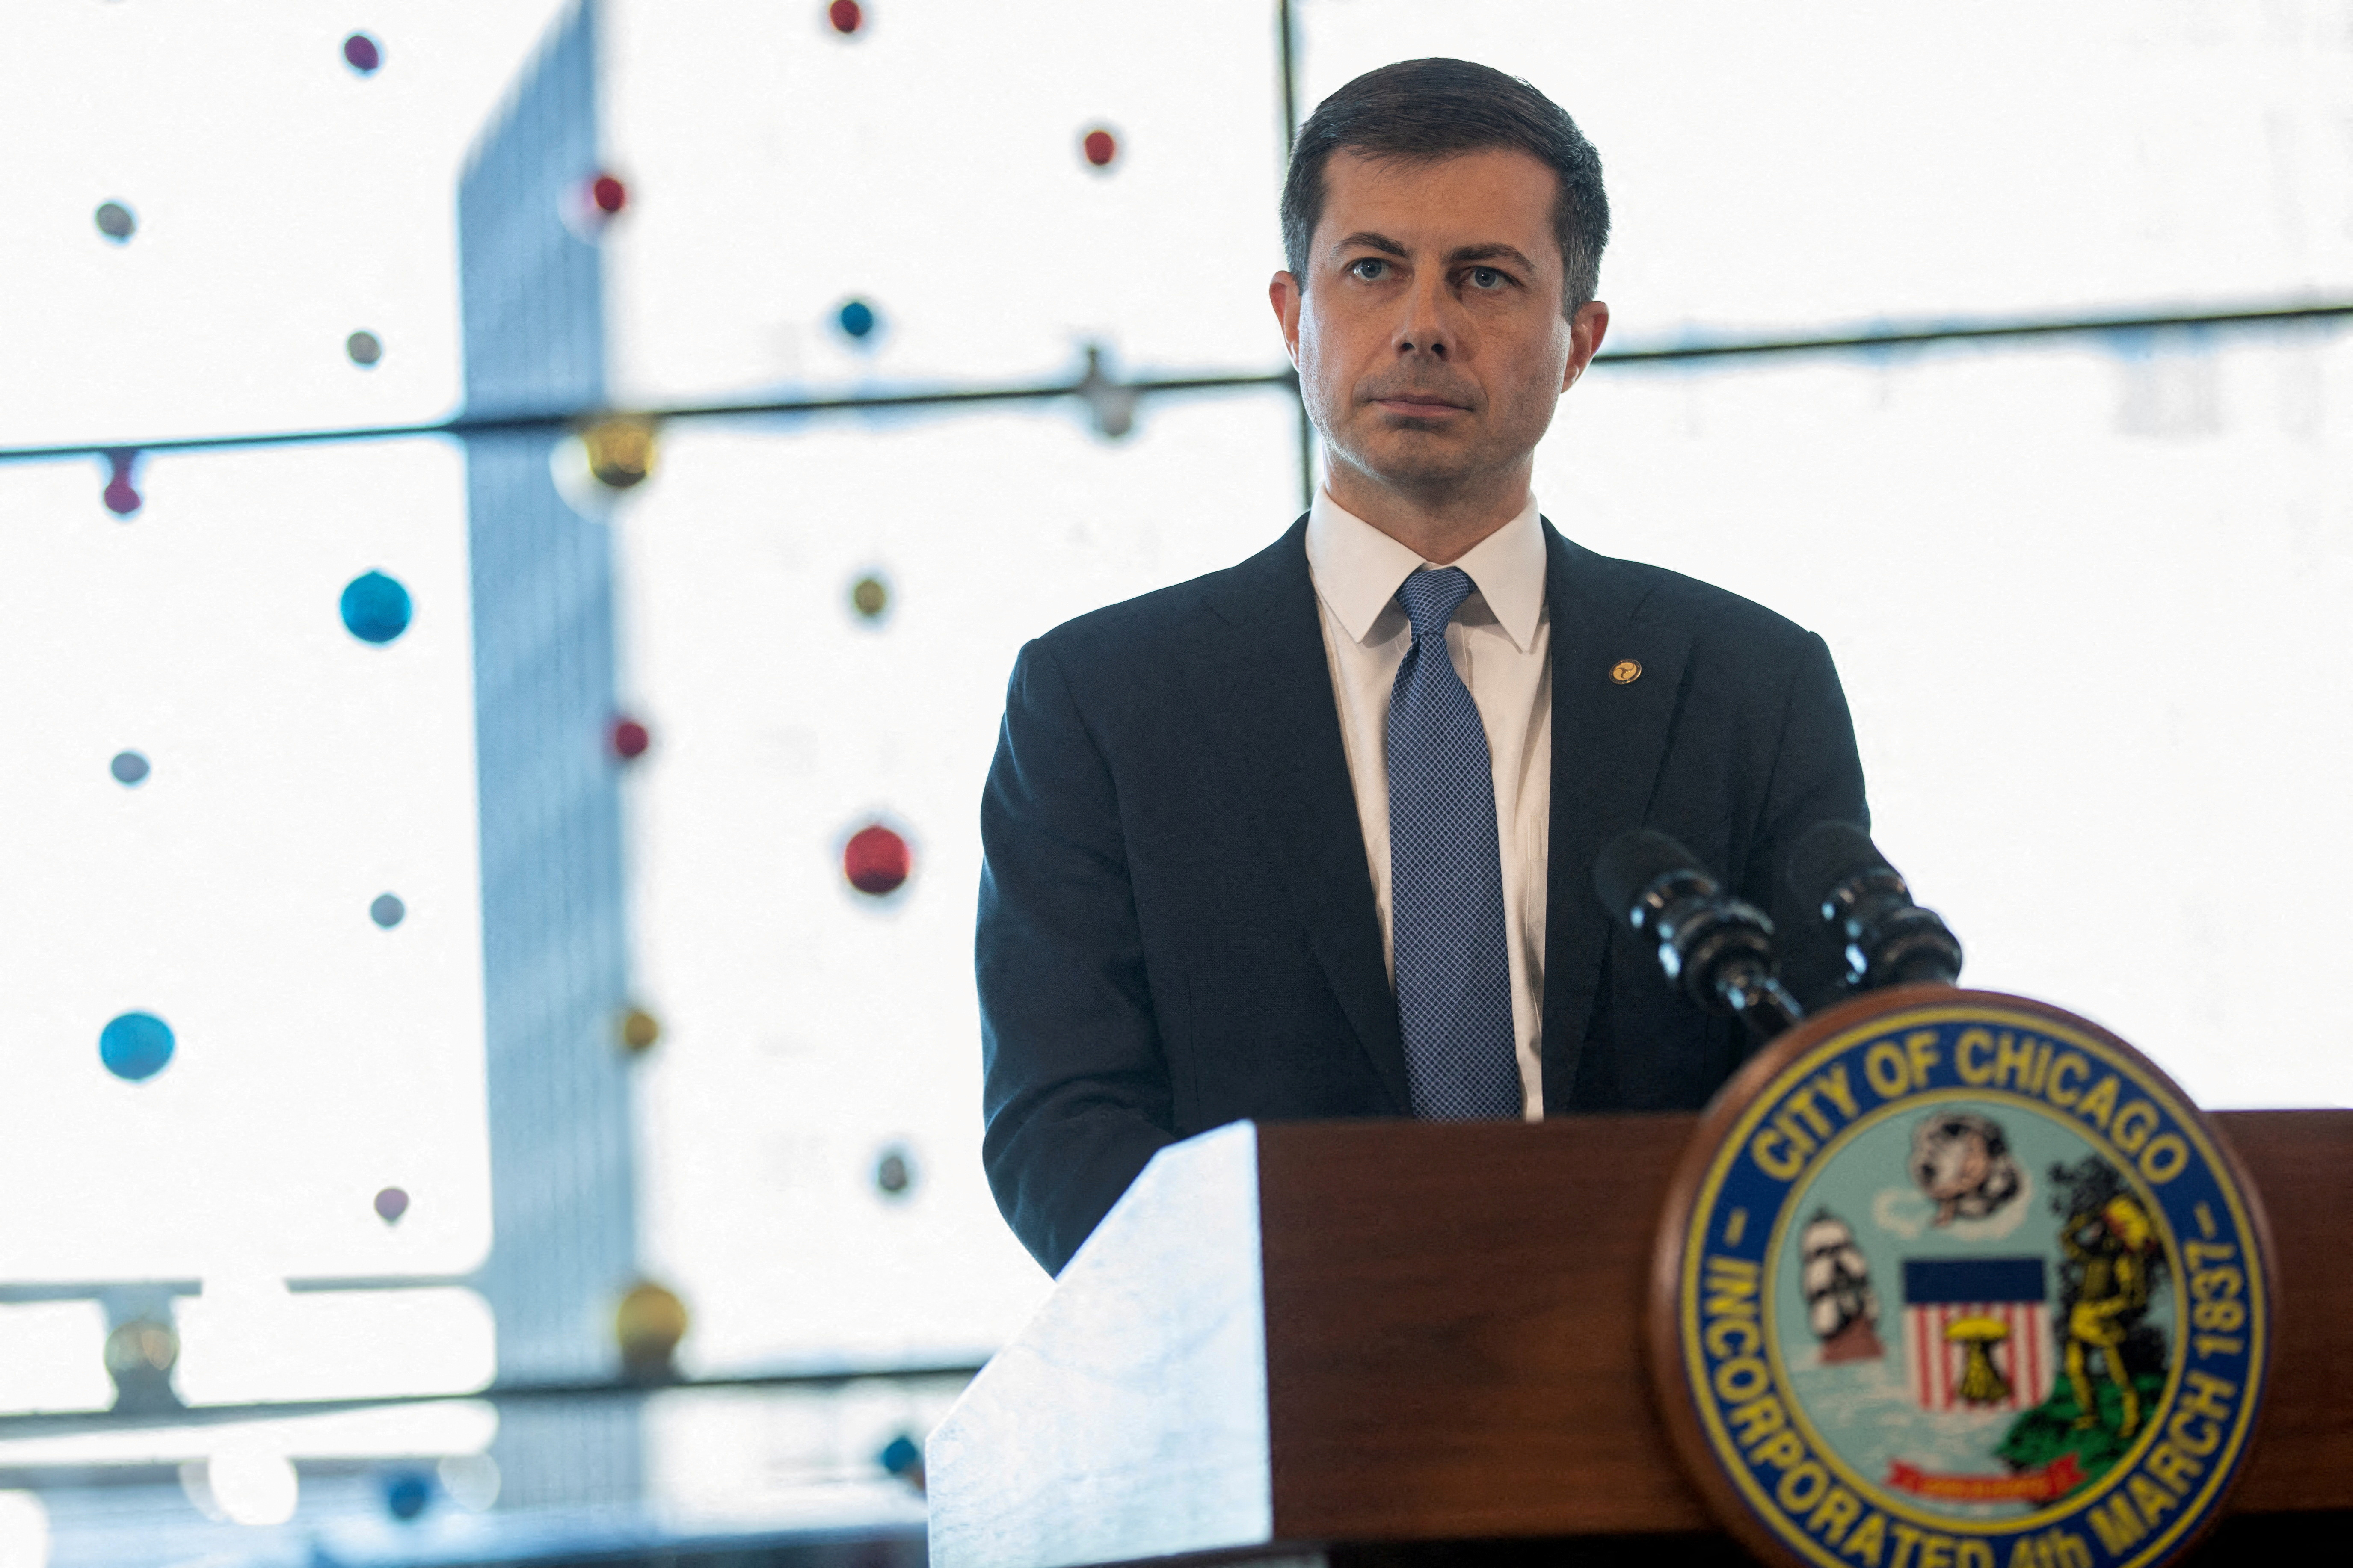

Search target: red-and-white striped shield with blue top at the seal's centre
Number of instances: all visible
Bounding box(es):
[1904,1257,2057,1411]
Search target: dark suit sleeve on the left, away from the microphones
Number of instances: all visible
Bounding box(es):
[974,642,1174,1274]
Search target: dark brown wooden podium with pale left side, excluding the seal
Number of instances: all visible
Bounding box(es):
[927,1112,2353,1568]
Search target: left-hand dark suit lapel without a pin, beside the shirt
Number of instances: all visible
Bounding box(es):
[1200,517,1412,1114]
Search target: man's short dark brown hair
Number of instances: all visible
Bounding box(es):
[1283,59,1609,315]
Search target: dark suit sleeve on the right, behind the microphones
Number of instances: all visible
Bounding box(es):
[1741,632,1871,1009]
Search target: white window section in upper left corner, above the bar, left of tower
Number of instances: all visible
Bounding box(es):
[0,0,574,444]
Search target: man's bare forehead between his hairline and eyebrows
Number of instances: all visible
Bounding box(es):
[1316,148,1560,266]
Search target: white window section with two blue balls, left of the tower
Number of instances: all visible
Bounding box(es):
[0,442,489,1281]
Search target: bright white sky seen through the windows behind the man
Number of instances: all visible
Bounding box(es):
[0,0,2353,1476]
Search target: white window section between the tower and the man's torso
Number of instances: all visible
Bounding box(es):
[619,393,1299,1370]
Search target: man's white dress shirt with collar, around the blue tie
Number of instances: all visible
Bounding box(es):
[1308,489,1553,1121]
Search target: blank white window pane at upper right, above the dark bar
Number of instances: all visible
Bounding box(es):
[1294,0,2353,343]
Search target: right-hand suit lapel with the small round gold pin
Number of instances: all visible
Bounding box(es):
[1544,522,1689,1112]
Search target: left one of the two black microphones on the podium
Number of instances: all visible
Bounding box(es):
[1593,828,1805,1039]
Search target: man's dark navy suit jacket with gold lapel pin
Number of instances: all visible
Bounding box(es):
[977,517,1866,1272]
